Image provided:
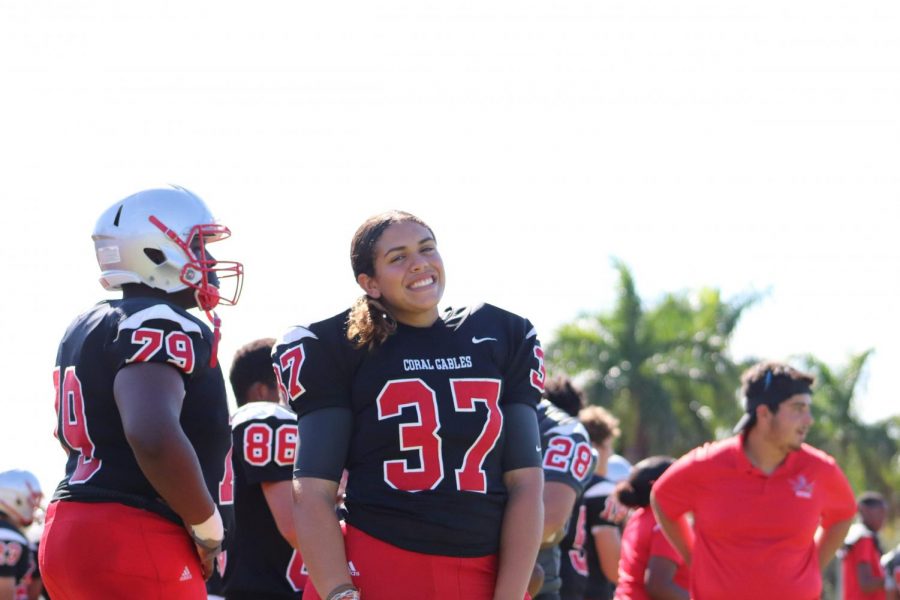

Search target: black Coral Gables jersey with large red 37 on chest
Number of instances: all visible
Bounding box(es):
[274,304,545,557]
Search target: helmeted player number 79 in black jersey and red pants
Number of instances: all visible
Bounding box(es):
[39,186,243,600]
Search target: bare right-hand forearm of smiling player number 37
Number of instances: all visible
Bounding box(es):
[494,467,544,600]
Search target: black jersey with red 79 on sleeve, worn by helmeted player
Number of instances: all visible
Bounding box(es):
[53,298,231,524]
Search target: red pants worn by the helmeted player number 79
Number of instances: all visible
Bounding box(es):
[38,501,206,600]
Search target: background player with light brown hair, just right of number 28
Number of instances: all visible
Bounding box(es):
[578,406,631,600]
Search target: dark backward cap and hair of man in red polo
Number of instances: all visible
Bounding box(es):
[741,361,815,432]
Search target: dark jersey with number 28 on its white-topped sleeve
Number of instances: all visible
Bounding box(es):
[537,400,597,594]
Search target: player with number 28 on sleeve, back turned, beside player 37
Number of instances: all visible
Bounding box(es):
[535,377,597,600]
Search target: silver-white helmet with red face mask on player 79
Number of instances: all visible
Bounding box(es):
[92,186,244,312]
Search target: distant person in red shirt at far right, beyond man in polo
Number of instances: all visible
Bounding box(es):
[841,492,887,600]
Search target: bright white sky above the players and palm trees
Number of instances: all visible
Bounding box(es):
[0,0,900,491]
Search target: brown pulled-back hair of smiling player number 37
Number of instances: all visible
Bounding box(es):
[347,210,436,348]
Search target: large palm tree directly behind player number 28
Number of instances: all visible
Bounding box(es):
[547,260,757,459]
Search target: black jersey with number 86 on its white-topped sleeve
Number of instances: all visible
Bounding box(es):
[225,402,306,600]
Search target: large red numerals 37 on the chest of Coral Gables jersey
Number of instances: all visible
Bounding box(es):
[376,379,503,493]
